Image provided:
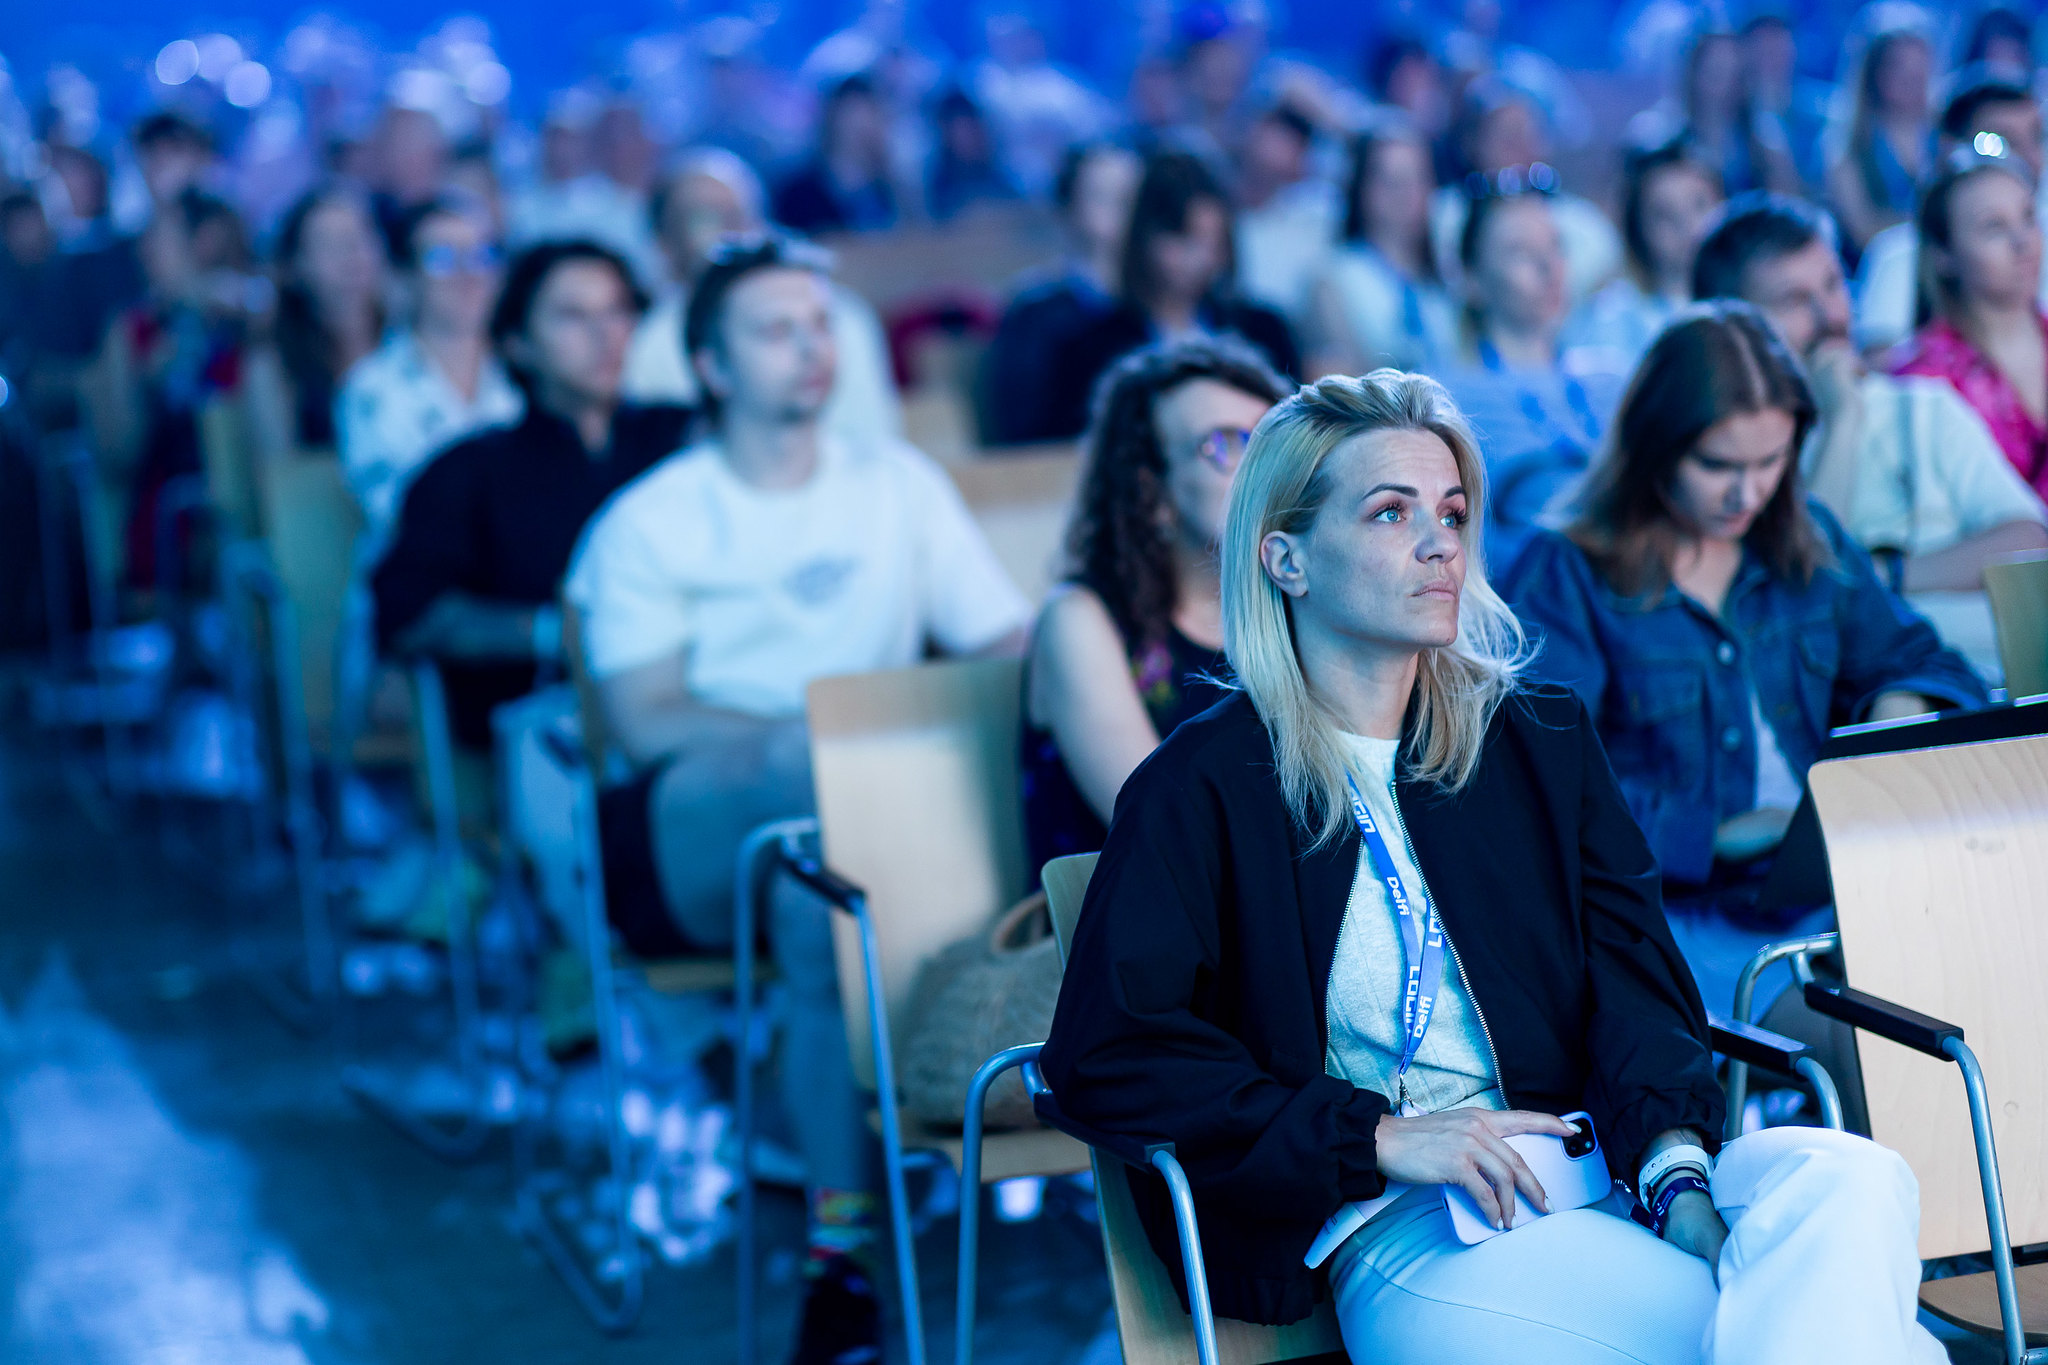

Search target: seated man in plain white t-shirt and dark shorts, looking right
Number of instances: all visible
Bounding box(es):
[567,239,1030,1361]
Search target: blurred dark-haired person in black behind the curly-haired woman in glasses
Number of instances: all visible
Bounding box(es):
[1051,151,1300,436]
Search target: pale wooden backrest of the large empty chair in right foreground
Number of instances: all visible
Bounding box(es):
[1808,735,2048,1259]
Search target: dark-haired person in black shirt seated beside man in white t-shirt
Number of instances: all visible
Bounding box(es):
[371,241,690,749]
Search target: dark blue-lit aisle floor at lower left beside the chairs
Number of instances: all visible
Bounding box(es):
[0,731,1108,1365]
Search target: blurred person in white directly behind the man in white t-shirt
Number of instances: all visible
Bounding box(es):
[625,147,903,442]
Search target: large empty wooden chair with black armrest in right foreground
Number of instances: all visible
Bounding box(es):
[1765,735,2048,1365]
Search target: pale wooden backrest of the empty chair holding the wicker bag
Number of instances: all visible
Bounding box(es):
[805,659,1036,1089]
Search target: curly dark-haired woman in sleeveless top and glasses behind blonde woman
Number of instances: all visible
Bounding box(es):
[1024,342,1286,874]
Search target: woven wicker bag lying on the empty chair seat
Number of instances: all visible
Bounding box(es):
[901,890,1059,1132]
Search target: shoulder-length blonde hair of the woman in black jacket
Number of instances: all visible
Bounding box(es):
[1221,370,1530,845]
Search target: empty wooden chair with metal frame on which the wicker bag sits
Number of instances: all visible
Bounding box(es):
[790,661,1087,1365]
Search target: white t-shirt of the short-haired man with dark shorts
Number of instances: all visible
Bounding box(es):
[567,434,1030,716]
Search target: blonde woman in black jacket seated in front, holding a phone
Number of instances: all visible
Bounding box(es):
[1042,370,1946,1365]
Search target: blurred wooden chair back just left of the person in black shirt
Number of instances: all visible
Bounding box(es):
[260,454,362,753]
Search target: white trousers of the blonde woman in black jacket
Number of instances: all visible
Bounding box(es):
[1329,1128,1948,1365]
